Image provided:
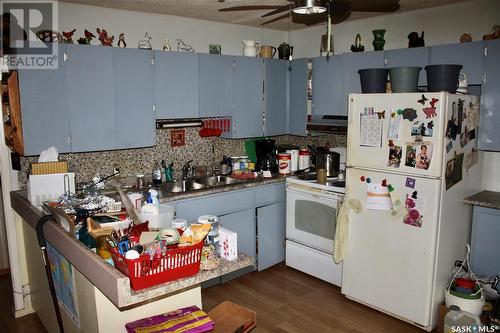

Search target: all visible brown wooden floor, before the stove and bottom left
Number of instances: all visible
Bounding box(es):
[0,264,432,333]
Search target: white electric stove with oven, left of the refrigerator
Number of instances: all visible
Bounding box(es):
[286,177,345,286]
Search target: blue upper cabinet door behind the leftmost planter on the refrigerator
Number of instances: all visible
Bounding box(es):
[342,51,384,116]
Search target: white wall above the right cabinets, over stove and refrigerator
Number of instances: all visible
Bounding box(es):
[291,0,500,58]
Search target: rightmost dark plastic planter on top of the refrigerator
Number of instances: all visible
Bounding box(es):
[425,65,462,93]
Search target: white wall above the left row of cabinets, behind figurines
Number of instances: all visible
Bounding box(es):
[58,0,288,55]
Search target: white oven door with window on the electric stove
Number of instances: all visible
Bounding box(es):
[286,184,343,253]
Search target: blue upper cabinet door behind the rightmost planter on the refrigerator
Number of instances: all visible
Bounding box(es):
[430,41,484,84]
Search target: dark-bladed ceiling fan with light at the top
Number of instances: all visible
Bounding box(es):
[218,0,399,25]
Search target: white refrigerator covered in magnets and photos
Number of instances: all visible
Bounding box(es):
[342,92,482,331]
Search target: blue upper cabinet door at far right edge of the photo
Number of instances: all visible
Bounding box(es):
[478,40,500,151]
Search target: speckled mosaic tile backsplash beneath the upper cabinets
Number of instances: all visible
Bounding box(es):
[19,127,346,188]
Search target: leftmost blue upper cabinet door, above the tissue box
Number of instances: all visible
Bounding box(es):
[18,44,71,156]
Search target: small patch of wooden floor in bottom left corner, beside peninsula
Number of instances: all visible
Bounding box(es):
[0,274,47,333]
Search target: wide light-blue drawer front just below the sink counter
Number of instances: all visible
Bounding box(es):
[174,189,254,220]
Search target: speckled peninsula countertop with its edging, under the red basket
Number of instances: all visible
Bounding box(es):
[11,191,255,310]
